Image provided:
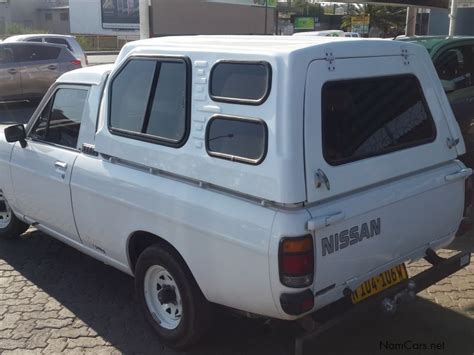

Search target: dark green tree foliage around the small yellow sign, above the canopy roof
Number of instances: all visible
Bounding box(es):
[341,4,406,37]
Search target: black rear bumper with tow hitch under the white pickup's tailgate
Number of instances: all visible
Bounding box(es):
[297,249,471,348]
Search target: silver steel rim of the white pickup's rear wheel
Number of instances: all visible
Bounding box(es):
[144,265,183,330]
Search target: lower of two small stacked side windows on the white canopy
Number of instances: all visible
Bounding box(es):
[206,116,267,164]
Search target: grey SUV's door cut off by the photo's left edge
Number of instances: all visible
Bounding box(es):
[0,45,21,101]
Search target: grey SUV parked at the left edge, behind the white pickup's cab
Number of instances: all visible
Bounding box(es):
[0,42,82,102]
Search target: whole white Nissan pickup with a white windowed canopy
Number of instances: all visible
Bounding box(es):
[0,36,472,348]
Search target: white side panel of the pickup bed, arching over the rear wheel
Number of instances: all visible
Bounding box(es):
[71,154,279,317]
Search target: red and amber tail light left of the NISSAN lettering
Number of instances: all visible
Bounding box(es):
[278,235,314,288]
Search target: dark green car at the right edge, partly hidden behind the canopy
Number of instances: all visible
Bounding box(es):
[397,36,474,168]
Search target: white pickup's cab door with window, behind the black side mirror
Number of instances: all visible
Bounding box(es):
[11,85,89,242]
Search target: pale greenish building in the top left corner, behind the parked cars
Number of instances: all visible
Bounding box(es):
[0,0,70,35]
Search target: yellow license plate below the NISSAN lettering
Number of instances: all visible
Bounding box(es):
[351,264,408,304]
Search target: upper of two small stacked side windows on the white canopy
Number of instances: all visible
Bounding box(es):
[210,62,271,104]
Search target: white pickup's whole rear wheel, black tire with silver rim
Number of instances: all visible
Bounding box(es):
[135,245,212,350]
